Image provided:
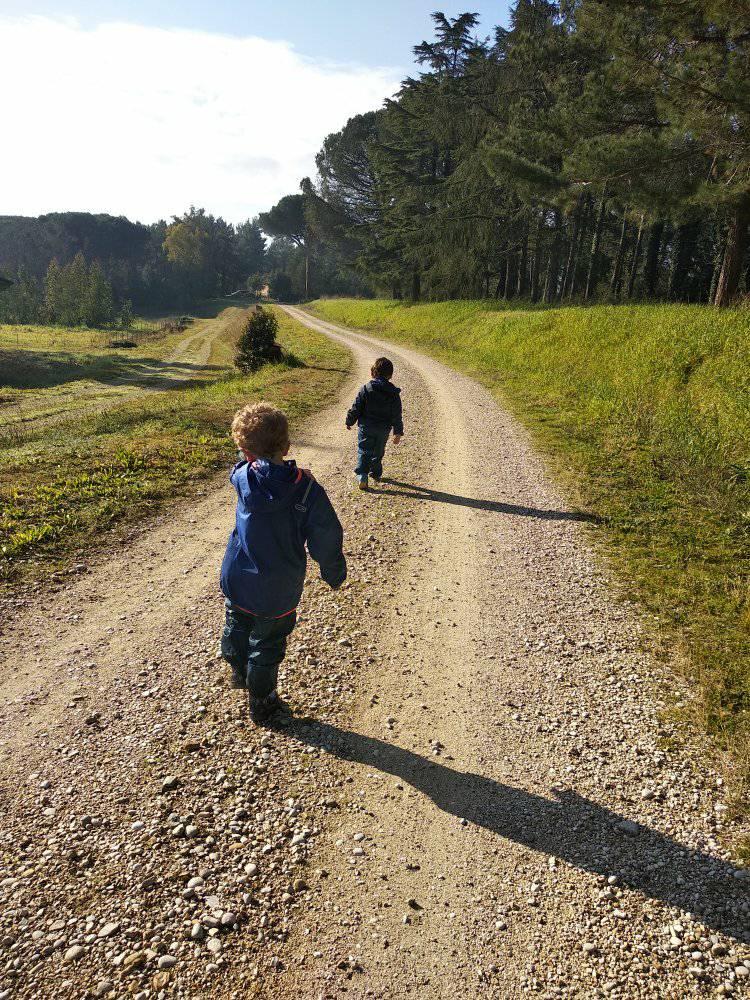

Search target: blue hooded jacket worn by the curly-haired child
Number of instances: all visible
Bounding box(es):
[221,459,346,618]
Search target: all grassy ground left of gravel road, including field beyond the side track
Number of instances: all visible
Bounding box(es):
[0,308,349,591]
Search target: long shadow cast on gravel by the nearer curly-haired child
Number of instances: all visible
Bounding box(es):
[287,719,750,943]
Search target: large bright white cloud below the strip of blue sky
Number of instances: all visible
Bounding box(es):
[0,17,398,222]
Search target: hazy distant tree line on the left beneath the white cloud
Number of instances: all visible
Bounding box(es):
[0,208,267,326]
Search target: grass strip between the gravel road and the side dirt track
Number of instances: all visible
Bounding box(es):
[0,312,349,591]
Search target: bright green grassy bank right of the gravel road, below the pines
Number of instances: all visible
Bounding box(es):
[314,299,750,804]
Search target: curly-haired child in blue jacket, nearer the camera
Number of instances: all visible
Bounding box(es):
[221,403,346,725]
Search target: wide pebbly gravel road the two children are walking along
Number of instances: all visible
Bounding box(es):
[0,309,750,1000]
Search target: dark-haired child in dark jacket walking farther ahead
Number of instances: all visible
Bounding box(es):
[346,358,404,490]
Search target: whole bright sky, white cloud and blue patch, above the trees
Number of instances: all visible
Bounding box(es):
[0,0,507,222]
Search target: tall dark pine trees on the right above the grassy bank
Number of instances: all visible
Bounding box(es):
[268,0,750,305]
